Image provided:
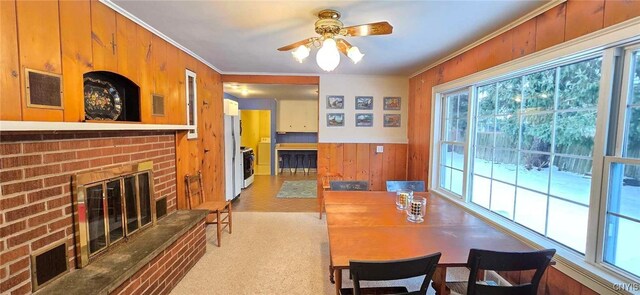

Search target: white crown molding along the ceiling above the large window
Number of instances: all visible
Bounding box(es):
[409,0,567,78]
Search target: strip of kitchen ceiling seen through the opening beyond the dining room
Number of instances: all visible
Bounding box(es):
[224,83,318,100]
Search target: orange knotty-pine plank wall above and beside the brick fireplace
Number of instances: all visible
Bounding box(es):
[0,0,224,209]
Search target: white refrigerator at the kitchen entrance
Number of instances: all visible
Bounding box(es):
[224,99,244,201]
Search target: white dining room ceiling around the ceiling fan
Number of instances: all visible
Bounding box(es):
[112,0,546,76]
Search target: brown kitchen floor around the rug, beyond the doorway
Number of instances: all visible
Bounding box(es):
[233,172,318,212]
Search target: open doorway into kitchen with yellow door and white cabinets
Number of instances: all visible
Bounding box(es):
[223,82,319,212]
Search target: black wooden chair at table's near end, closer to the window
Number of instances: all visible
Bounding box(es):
[447,249,556,295]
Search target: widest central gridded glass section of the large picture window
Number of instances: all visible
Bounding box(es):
[471,57,602,253]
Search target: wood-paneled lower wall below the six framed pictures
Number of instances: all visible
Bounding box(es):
[318,143,407,198]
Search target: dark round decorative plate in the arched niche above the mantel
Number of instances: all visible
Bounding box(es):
[84,78,122,120]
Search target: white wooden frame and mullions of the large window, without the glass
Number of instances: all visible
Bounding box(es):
[428,19,640,292]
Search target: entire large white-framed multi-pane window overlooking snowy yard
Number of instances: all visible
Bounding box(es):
[430,31,640,282]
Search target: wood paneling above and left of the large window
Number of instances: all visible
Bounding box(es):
[408,0,640,185]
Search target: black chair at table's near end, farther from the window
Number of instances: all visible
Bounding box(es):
[340,252,441,295]
